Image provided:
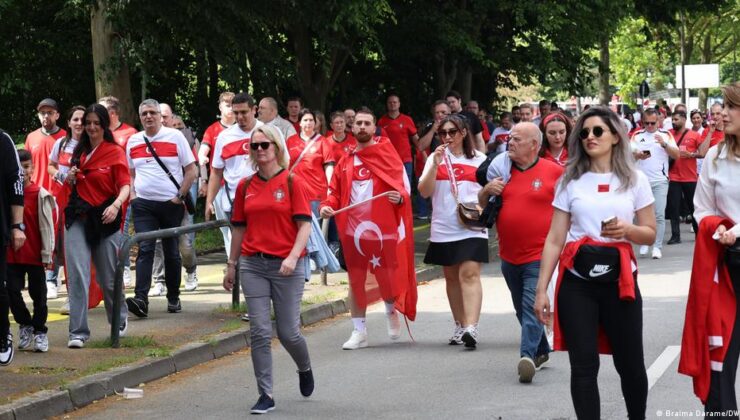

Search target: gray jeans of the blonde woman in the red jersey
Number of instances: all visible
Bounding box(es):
[239,256,311,395]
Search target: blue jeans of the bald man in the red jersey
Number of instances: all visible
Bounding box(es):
[501,260,550,360]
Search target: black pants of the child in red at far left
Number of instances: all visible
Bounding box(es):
[6,264,49,334]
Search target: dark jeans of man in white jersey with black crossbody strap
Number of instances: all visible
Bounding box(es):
[131,198,185,302]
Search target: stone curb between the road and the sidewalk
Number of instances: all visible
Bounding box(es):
[0,266,442,420]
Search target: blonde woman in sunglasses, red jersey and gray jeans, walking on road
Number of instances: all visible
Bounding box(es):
[224,125,314,414]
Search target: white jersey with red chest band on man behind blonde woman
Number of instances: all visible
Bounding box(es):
[211,121,262,194]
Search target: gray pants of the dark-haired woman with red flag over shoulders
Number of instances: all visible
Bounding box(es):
[64,220,128,341]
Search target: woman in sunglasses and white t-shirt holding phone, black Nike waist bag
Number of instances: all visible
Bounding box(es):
[534,107,655,419]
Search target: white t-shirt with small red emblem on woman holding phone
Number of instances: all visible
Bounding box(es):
[552,171,655,242]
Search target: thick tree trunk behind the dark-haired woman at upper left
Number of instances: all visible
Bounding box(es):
[90,0,137,123]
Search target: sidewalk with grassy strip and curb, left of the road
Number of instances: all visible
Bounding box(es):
[0,221,482,420]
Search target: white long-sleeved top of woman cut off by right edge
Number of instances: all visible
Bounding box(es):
[694,145,740,237]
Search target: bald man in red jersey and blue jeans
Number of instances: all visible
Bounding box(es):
[478,122,563,383]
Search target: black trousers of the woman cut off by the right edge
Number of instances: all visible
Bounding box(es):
[704,251,740,419]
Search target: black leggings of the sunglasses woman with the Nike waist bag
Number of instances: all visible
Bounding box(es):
[557,271,647,420]
